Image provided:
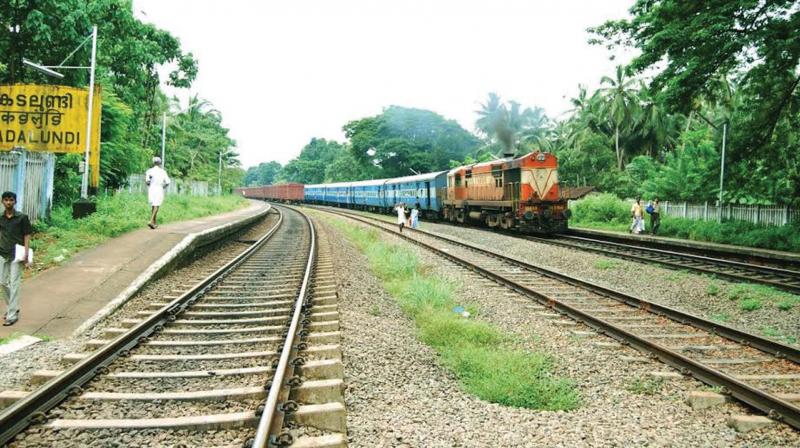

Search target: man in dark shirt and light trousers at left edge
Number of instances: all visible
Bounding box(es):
[0,191,33,326]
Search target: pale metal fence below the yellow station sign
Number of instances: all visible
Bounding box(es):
[0,150,56,222]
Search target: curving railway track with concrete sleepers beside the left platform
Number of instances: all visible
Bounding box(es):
[0,208,346,448]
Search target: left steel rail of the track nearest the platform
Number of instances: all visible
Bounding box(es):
[0,210,283,446]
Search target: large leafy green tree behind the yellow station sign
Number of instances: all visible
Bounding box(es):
[0,0,209,202]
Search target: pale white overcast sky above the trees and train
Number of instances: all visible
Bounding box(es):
[134,0,633,167]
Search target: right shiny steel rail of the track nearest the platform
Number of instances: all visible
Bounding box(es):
[252,206,317,448]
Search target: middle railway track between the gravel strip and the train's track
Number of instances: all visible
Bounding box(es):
[322,208,800,429]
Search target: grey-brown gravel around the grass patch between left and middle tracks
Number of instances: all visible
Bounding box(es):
[320,213,800,447]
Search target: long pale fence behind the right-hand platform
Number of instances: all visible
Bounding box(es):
[661,201,800,226]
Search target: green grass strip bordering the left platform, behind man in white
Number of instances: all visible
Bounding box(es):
[31,193,247,271]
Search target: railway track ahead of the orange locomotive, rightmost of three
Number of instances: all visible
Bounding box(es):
[515,234,800,294]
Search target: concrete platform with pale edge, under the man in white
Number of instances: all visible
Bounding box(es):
[0,201,268,338]
